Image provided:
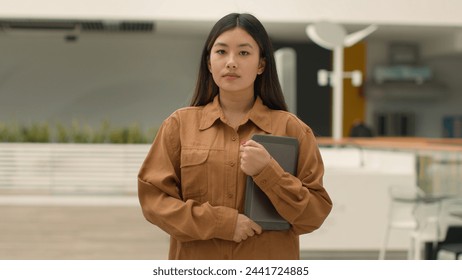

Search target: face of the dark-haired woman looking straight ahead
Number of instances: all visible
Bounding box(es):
[209,28,265,94]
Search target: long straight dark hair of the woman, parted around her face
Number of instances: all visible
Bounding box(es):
[191,13,287,111]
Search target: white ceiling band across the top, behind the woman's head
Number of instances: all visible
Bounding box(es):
[0,0,462,54]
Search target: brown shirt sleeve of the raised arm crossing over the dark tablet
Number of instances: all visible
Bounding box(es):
[253,129,332,234]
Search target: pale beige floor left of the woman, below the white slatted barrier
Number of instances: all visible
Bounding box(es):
[0,196,168,260]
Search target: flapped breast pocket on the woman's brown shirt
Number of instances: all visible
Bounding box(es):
[180,148,209,202]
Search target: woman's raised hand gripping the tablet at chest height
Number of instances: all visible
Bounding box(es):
[239,140,271,176]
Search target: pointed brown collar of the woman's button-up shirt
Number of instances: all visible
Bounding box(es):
[199,95,271,133]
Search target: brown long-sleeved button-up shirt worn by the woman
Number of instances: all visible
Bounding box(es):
[138,97,332,259]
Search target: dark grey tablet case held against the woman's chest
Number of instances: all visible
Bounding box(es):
[244,134,298,230]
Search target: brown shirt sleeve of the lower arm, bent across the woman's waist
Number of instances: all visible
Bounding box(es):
[138,115,238,242]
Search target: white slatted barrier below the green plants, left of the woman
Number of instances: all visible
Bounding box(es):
[0,143,150,194]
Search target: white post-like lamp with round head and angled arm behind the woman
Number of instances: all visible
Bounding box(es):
[306,21,377,140]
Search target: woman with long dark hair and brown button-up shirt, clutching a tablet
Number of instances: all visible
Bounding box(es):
[138,13,332,259]
